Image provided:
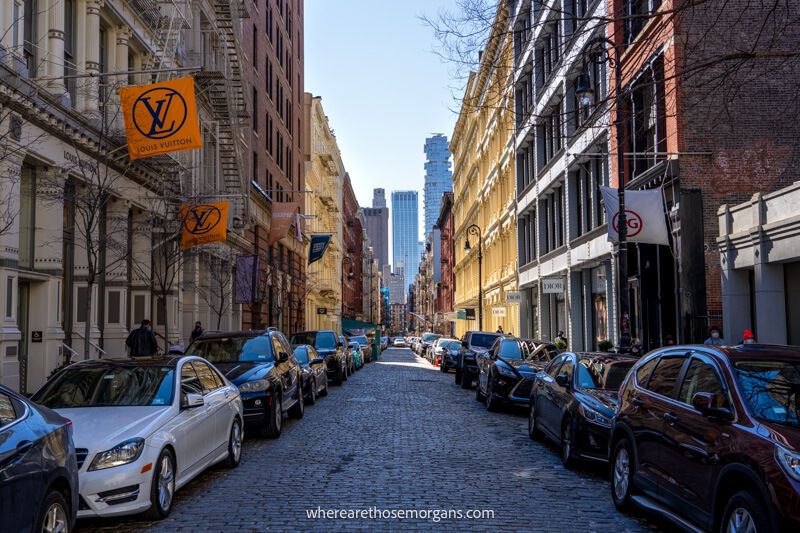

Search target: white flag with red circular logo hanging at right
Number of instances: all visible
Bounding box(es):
[600,187,669,245]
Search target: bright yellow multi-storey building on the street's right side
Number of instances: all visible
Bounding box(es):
[450,2,519,337]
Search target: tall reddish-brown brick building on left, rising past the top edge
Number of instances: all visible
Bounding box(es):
[242,0,306,335]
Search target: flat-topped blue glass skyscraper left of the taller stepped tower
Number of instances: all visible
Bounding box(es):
[392,191,419,288]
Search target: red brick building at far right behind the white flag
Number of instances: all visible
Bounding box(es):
[607,0,800,348]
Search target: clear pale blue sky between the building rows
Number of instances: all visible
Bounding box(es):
[305,0,456,250]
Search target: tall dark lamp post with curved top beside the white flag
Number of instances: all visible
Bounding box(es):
[575,37,630,345]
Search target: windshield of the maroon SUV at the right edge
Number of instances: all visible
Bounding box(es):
[733,361,800,427]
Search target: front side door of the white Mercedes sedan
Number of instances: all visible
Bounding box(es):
[175,361,215,474]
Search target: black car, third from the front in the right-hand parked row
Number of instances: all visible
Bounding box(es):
[475,336,558,411]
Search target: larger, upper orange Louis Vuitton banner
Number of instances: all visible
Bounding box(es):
[119,76,203,159]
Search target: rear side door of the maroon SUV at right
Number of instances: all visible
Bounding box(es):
[629,353,687,491]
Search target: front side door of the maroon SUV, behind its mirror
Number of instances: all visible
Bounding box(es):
[661,354,731,523]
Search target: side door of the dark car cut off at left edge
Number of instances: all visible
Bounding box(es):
[0,391,44,531]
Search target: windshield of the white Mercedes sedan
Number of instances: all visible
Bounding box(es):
[33,365,175,409]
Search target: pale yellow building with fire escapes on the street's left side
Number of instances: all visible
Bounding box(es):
[303,93,345,331]
